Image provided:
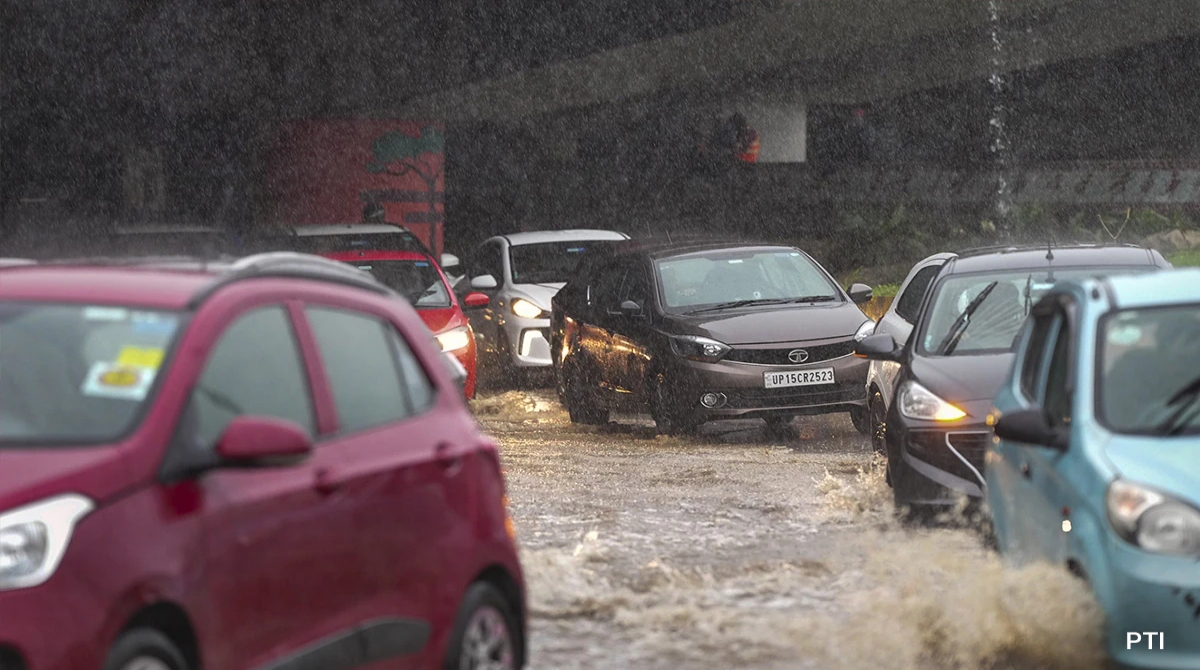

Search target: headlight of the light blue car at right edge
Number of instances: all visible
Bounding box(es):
[1105,479,1200,556]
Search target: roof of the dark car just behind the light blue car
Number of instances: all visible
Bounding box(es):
[943,244,1168,274]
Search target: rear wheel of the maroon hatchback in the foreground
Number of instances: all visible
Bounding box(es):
[444,582,518,670]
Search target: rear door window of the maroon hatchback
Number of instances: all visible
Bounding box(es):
[305,307,414,433]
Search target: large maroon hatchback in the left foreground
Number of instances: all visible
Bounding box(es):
[0,253,527,670]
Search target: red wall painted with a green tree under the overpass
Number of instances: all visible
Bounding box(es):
[260,119,445,253]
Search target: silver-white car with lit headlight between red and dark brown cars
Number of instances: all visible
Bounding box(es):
[464,229,629,376]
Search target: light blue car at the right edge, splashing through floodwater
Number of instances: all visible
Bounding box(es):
[984,270,1200,669]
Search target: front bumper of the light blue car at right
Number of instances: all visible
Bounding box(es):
[1088,537,1200,669]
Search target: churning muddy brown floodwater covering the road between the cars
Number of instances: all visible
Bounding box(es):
[473,390,1104,670]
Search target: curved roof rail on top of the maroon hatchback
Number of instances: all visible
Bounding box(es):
[187,251,398,309]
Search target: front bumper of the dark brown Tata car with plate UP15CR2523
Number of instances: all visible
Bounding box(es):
[671,355,868,419]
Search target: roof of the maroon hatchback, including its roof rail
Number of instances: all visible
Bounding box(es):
[0,252,395,310]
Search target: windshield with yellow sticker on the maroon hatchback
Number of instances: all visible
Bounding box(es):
[0,303,182,444]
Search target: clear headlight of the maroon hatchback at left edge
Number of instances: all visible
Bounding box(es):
[0,493,95,591]
